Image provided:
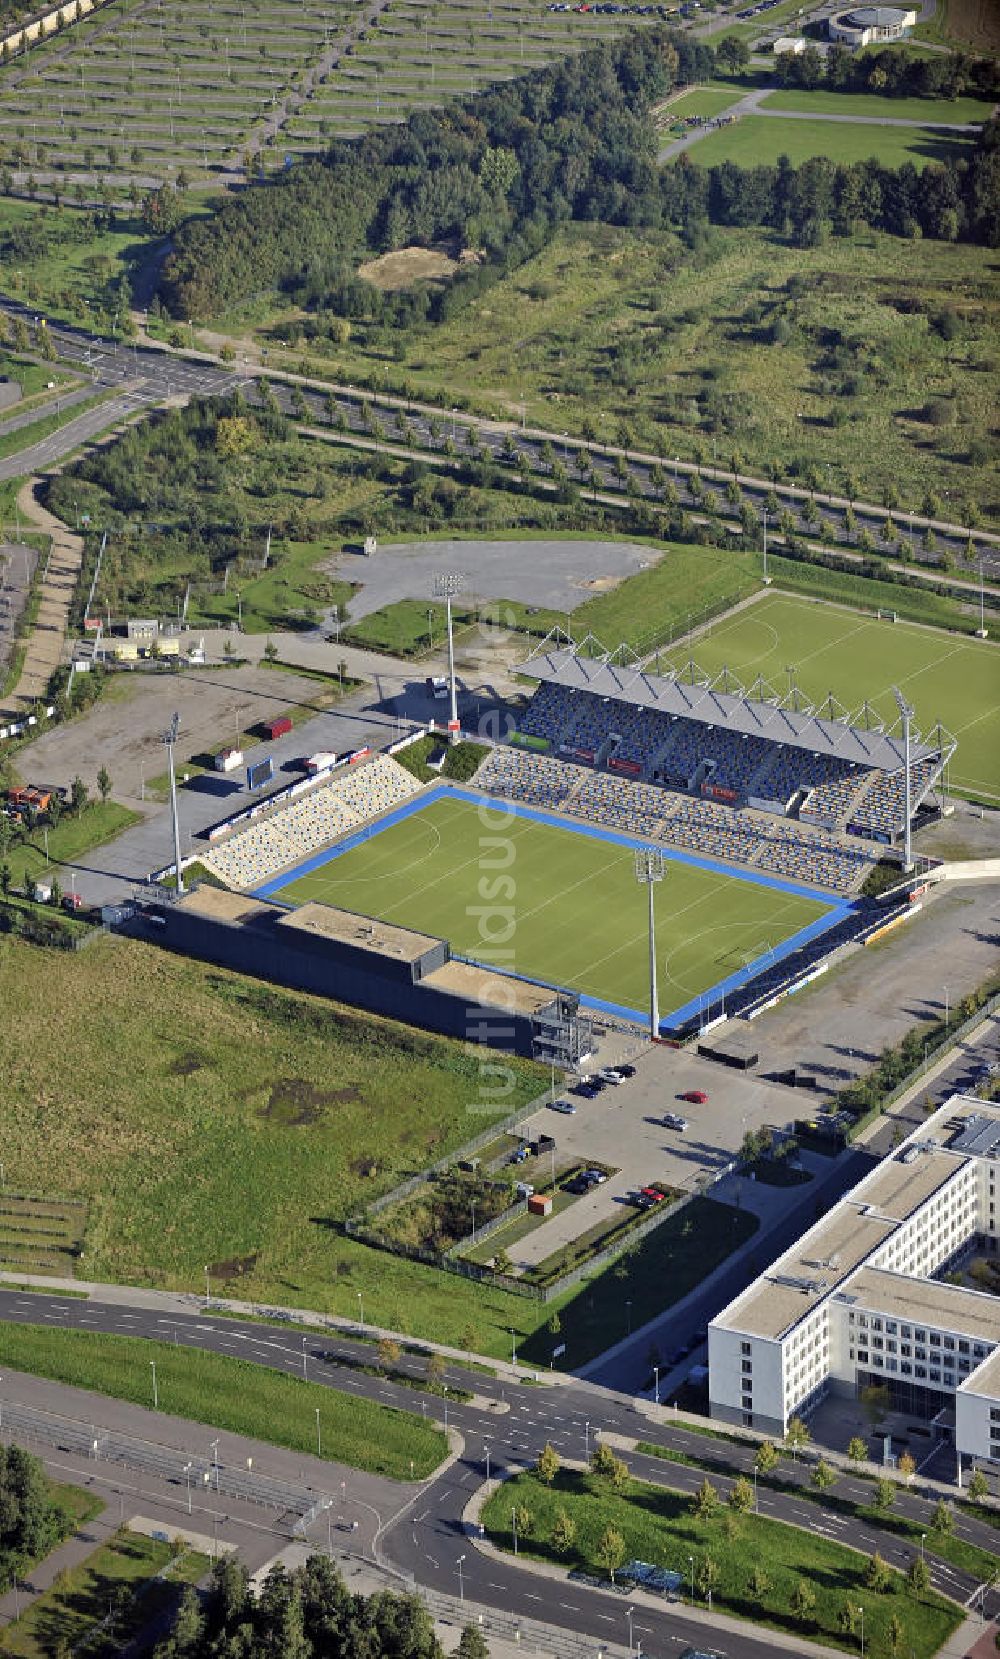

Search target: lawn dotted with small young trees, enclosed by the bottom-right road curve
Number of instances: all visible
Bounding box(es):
[483,1470,962,1659]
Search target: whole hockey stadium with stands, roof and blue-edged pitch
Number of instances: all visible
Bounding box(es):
[146,634,955,1058]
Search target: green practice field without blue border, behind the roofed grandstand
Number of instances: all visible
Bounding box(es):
[693,592,1000,801]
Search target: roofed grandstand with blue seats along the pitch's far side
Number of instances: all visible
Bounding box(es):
[512,640,955,858]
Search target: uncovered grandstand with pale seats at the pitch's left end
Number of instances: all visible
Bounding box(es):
[201,755,420,891]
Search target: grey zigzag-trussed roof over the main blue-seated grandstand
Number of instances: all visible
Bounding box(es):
[521,647,937,771]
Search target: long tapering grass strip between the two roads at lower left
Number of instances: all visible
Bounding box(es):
[3,1324,446,1480]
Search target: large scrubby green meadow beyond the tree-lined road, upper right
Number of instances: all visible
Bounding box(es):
[270,222,1000,521]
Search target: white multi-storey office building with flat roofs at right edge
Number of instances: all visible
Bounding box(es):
[708,1095,1000,1465]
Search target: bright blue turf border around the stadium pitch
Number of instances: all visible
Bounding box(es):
[254,783,854,1029]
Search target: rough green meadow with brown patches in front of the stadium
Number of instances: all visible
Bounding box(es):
[0,937,755,1360]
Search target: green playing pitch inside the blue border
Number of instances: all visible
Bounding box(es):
[268,800,828,1014]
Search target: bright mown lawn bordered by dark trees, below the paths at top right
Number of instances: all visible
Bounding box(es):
[690,114,973,168]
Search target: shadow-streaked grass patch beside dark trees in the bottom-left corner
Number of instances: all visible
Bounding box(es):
[3,1531,209,1659]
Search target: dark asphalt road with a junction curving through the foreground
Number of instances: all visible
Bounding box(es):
[0,1291,995,1659]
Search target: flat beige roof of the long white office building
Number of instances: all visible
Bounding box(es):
[713,1097,1000,1342]
